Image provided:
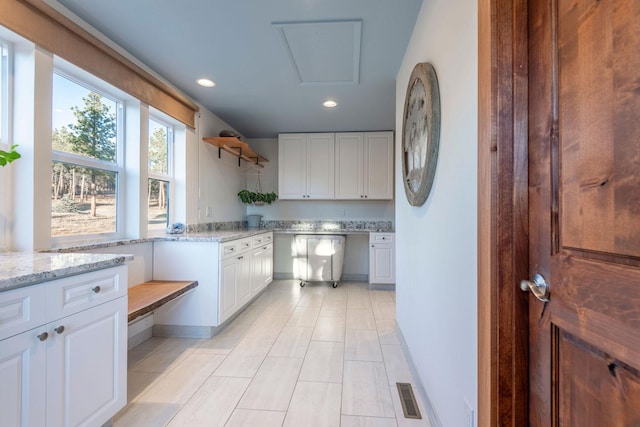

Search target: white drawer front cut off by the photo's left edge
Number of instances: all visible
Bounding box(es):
[0,285,47,340]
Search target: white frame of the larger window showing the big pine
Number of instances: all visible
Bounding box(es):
[49,67,129,247]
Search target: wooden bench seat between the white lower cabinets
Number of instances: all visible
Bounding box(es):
[128,280,198,322]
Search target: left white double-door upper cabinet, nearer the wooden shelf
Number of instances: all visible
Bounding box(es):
[278,133,335,200]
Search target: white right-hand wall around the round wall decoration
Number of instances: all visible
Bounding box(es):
[396,0,478,426]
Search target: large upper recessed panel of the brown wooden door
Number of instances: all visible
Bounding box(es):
[557,0,640,257]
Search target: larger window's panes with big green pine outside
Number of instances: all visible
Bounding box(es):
[51,72,123,237]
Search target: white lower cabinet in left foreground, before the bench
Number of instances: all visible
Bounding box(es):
[0,266,127,427]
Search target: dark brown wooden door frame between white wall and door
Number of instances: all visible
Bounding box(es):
[478,0,529,427]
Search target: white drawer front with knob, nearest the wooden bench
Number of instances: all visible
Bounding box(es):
[47,266,127,321]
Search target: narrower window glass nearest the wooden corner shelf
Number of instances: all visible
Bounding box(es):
[147,117,173,230]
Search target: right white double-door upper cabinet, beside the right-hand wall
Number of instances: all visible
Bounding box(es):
[335,132,393,200]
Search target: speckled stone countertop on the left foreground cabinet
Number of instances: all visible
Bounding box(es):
[0,252,133,292]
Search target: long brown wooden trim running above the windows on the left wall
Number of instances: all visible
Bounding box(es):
[0,0,199,128]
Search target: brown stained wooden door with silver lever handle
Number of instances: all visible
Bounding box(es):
[529,0,640,427]
